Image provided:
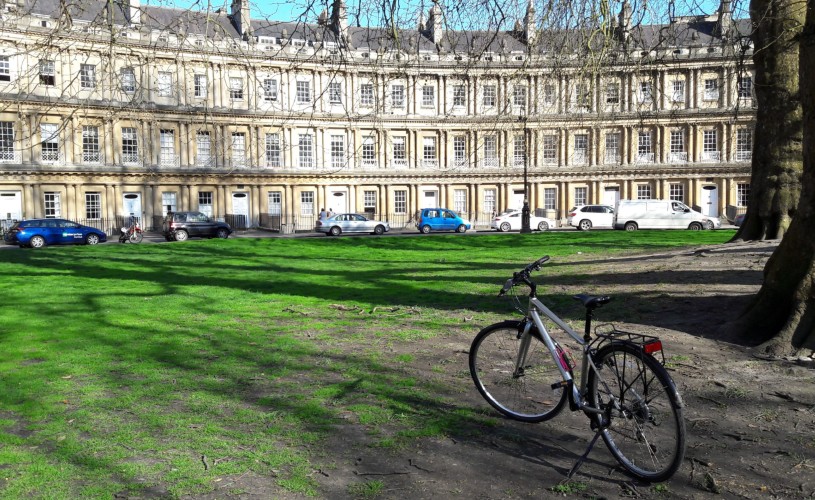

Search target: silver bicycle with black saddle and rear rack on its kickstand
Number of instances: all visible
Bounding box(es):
[470,256,685,482]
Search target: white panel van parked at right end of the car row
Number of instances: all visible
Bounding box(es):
[614,200,721,231]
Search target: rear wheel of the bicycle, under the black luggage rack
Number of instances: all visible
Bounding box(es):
[588,342,685,482]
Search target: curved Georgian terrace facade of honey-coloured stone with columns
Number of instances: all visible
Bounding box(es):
[0,1,754,230]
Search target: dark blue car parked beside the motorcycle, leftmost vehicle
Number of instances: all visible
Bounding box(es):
[3,219,107,248]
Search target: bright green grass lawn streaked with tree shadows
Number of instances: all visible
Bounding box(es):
[0,231,733,498]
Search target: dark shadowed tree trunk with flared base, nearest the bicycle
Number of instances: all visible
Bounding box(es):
[733,0,815,355]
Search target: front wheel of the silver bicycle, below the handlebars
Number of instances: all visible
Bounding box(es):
[470,321,566,422]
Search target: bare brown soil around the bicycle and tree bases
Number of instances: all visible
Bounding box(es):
[198,243,815,499]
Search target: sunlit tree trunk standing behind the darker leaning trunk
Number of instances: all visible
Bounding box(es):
[734,0,805,240]
